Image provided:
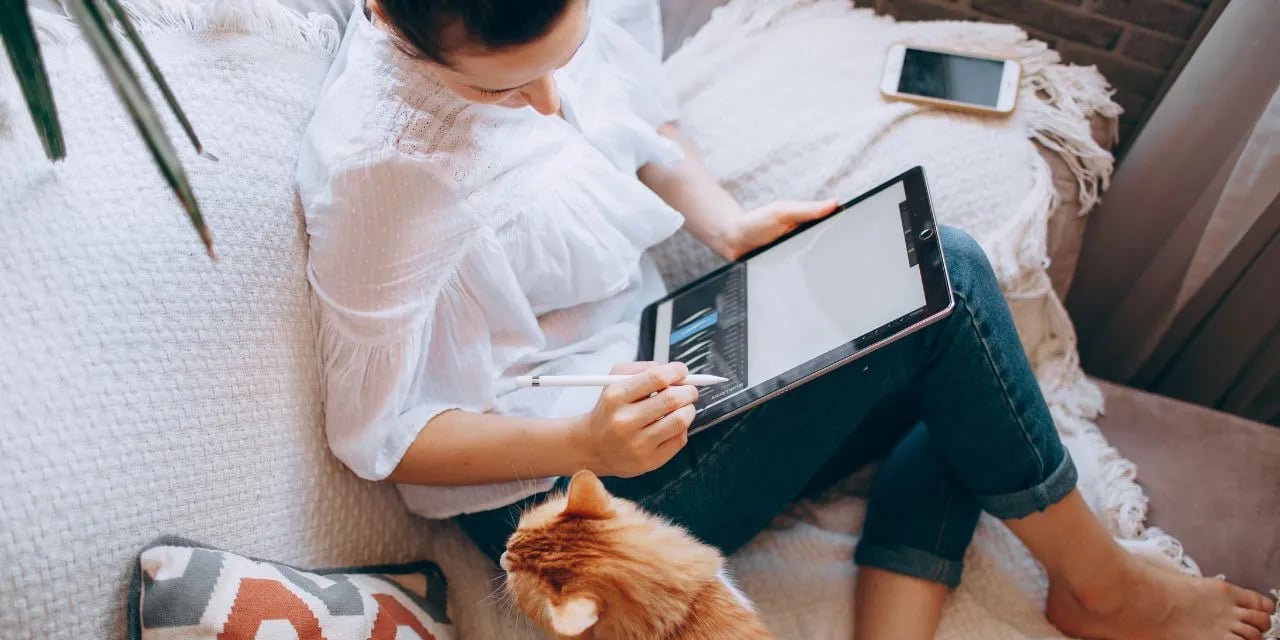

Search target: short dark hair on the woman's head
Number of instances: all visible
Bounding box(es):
[376,0,582,64]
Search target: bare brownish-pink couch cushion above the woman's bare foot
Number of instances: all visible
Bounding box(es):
[1098,381,1280,590]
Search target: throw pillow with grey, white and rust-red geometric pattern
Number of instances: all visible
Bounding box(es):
[129,538,454,640]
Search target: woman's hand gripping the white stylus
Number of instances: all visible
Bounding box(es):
[573,362,698,477]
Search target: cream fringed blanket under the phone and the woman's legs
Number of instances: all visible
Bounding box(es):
[650,0,1198,640]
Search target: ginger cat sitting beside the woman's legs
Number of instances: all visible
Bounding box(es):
[502,471,773,640]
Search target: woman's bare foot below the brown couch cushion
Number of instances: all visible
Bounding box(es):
[1047,558,1275,640]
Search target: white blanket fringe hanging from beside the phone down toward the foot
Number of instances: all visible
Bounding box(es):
[997,33,1167,575]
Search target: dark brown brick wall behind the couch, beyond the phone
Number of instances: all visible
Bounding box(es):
[855,0,1212,141]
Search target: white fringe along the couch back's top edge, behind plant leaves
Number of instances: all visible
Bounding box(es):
[31,0,342,58]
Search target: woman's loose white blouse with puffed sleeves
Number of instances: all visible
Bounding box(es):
[297,2,682,517]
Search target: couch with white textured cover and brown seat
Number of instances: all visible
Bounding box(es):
[0,0,1280,639]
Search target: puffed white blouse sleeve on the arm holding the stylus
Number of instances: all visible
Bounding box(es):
[300,151,543,480]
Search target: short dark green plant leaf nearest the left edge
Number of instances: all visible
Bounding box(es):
[0,0,67,160]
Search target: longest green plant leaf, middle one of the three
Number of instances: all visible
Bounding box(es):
[67,0,216,259]
